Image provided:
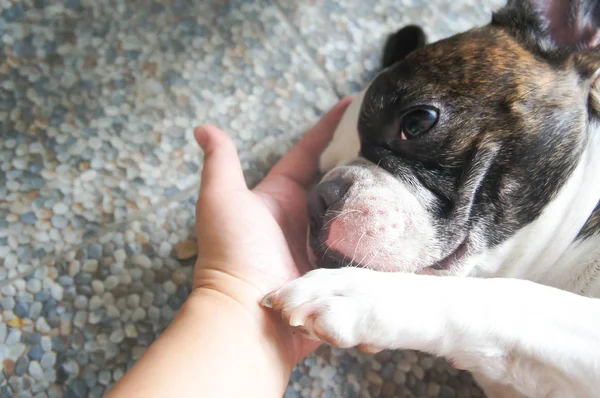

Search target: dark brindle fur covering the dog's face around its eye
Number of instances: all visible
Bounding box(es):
[359,5,600,249]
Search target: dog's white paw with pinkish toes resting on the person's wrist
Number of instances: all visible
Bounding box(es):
[262,268,385,352]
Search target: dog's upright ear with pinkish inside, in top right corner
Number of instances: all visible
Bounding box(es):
[492,0,600,52]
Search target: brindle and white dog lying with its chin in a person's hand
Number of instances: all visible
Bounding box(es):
[262,0,600,397]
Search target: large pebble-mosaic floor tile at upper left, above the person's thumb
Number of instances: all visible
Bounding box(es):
[0,0,336,280]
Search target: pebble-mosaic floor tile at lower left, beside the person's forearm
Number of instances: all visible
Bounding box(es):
[0,197,194,397]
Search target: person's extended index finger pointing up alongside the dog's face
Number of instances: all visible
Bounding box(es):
[267,97,352,186]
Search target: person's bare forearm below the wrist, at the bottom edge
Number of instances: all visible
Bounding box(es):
[109,290,293,398]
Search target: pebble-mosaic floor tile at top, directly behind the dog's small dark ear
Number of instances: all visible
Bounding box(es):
[280,0,506,94]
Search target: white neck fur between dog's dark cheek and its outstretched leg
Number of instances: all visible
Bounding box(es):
[472,124,600,293]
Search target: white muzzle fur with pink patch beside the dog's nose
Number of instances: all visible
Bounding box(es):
[318,159,443,272]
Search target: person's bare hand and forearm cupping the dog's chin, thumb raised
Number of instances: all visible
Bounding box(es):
[107,98,351,398]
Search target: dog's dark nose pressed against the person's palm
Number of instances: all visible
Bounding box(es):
[308,178,352,232]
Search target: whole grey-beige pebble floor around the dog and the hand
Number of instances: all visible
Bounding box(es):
[0,0,502,398]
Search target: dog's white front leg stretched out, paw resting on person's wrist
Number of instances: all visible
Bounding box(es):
[263,268,600,397]
